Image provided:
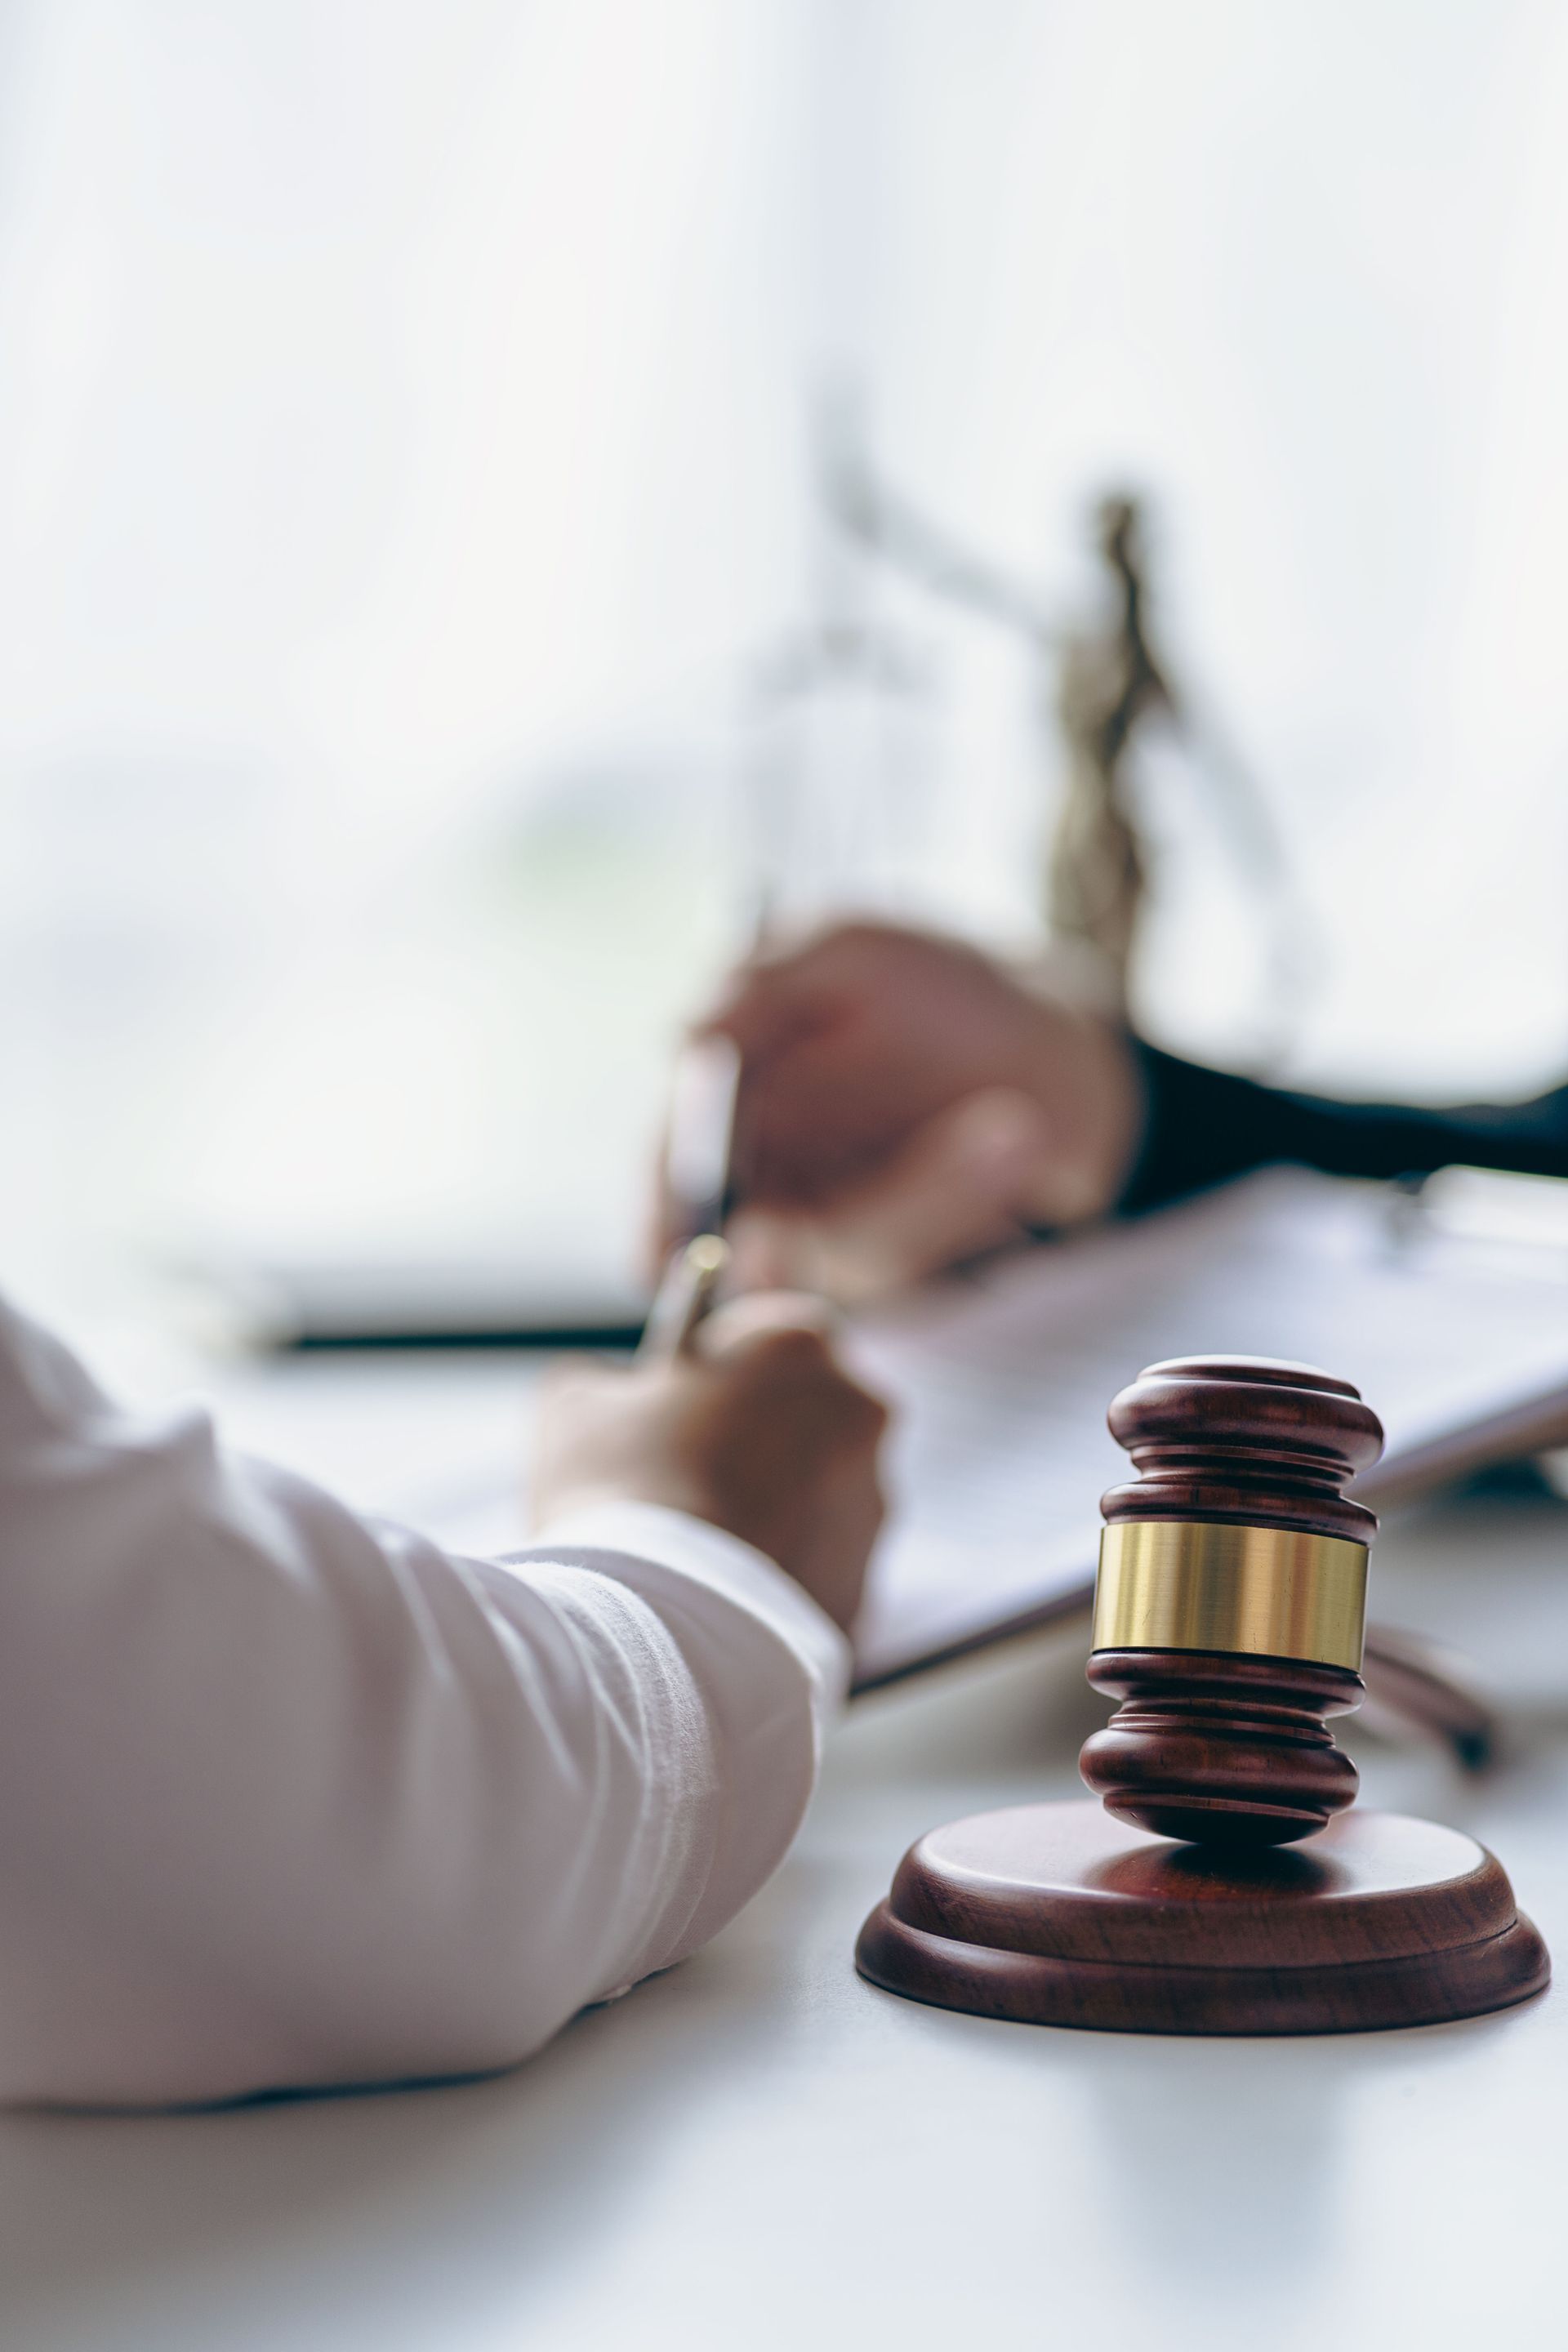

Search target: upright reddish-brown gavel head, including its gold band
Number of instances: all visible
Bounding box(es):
[1079,1355,1383,1849]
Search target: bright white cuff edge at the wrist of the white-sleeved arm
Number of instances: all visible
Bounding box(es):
[508,1500,853,1708]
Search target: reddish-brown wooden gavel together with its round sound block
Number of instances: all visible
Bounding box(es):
[856,1357,1552,2034]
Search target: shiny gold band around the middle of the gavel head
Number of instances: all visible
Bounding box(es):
[1094,1519,1365,1675]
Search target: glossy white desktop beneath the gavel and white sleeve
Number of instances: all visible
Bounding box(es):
[0,1371,1568,2352]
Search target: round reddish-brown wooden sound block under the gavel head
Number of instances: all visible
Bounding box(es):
[856,1804,1552,2034]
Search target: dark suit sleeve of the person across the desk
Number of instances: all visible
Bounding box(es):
[1119,1040,1568,1214]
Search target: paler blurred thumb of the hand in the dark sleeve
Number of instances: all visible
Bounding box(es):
[728,1087,1054,1301]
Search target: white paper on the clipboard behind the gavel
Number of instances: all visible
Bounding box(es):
[849,1169,1568,1689]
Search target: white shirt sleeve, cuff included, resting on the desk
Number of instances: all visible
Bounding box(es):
[0,1305,849,2105]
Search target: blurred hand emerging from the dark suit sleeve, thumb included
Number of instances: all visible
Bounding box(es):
[657,922,1143,1301]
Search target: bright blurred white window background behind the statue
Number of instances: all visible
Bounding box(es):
[0,0,1568,1335]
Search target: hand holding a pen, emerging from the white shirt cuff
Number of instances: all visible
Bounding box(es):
[532,1296,886,1630]
